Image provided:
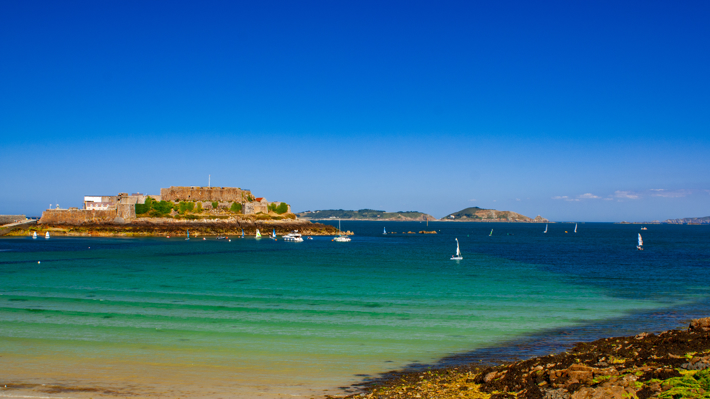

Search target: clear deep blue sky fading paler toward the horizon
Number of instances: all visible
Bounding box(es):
[0,0,710,221]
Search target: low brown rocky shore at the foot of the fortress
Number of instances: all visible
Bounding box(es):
[8,218,342,237]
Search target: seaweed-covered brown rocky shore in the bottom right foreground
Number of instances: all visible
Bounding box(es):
[326,318,710,399]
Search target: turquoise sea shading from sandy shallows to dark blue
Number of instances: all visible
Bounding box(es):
[0,221,710,398]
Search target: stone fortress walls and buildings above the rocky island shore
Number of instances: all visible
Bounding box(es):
[41,186,291,224]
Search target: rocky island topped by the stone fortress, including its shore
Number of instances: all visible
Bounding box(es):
[6,187,338,237]
